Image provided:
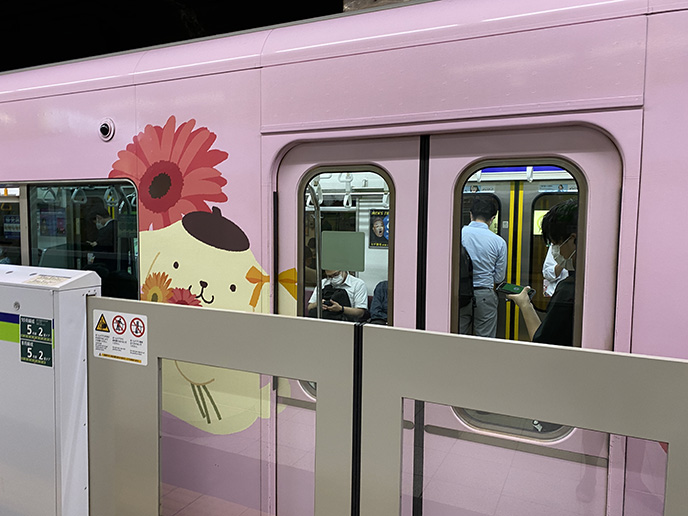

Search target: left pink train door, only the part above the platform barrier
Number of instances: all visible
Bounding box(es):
[277,137,420,328]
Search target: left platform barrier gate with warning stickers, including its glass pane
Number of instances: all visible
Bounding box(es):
[87,298,355,516]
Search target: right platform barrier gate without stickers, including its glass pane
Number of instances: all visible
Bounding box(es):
[361,327,688,516]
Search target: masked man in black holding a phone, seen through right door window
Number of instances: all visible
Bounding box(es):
[507,199,578,346]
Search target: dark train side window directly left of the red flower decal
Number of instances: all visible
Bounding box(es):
[28,182,139,299]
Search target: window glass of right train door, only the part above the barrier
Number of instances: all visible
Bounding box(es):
[455,165,582,345]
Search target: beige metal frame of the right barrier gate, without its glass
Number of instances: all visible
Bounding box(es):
[360,326,688,516]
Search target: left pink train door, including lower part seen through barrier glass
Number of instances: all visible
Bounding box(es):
[275,137,420,516]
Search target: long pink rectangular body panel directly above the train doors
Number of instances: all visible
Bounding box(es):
[262,18,646,132]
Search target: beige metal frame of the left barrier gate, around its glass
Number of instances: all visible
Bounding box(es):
[88,297,356,516]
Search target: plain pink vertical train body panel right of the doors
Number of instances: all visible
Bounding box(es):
[633,11,688,358]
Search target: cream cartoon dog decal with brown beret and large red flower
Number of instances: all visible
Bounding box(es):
[109,115,296,434]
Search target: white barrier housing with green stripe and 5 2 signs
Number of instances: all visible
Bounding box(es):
[0,265,100,516]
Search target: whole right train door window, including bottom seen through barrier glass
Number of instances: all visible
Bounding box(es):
[453,162,584,439]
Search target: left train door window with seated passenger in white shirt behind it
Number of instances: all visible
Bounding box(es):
[298,167,393,324]
